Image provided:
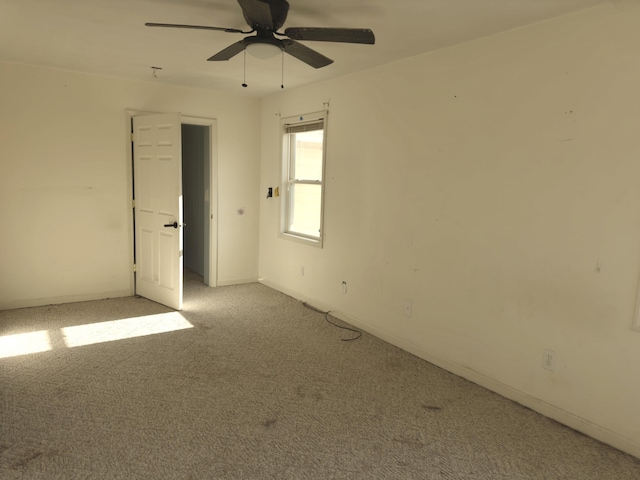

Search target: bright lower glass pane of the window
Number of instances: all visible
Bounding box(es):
[288,183,322,238]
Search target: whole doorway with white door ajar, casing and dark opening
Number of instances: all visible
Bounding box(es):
[127,110,218,310]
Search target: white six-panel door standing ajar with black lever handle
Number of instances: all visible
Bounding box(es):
[133,113,183,310]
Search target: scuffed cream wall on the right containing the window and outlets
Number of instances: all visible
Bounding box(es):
[260,2,640,456]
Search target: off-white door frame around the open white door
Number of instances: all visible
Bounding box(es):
[125,108,218,295]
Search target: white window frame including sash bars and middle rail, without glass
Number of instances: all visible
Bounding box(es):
[280,110,329,248]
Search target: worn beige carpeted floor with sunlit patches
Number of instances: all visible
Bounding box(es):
[0,275,640,480]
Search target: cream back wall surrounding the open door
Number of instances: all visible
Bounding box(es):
[0,64,260,309]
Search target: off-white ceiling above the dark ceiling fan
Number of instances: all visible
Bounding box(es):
[0,0,605,96]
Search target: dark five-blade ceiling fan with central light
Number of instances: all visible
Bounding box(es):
[145,0,375,68]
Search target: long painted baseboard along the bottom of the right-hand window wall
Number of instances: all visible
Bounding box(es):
[260,278,640,458]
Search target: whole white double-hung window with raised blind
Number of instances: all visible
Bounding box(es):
[282,112,326,245]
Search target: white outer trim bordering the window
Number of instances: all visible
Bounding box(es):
[279,110,329,248]
